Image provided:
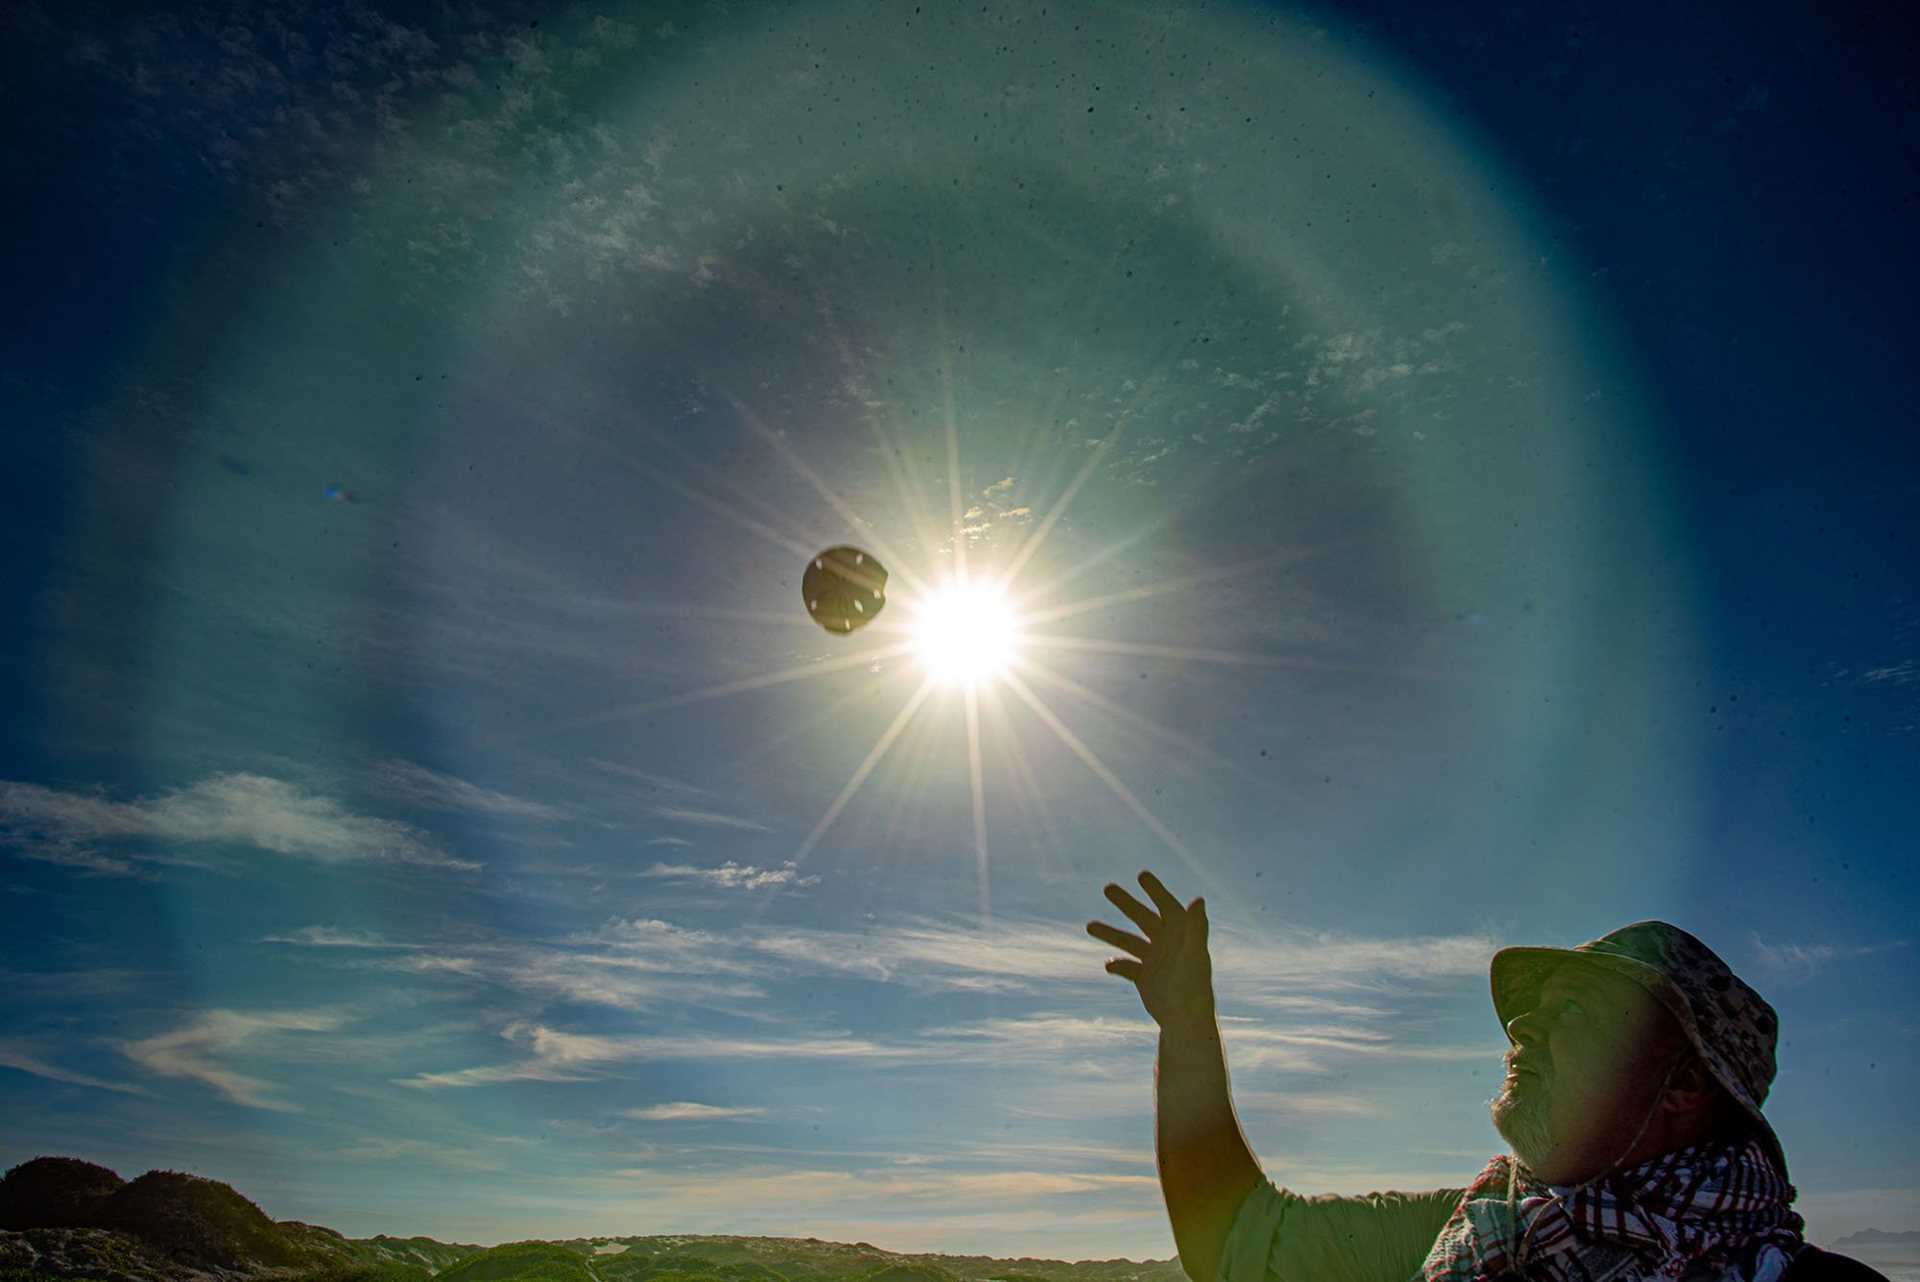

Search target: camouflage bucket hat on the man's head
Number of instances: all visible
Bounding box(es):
[1488,921,1788,1178]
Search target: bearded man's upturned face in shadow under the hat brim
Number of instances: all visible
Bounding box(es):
[1490,963,1680,1184]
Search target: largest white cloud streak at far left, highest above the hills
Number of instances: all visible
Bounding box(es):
[0,773,480,869]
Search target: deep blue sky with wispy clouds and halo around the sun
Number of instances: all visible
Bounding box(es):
[0,4,1920,1257]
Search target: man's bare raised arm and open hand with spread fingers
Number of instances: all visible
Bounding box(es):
[1087,871,1261,1282]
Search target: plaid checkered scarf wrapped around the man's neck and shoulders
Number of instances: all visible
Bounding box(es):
[1413,1142,1805,1282]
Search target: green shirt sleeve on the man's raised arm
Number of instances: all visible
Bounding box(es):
[1217,1180,1465,1282]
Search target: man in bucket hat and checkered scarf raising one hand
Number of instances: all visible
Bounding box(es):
[1087,871,1884,1282]
